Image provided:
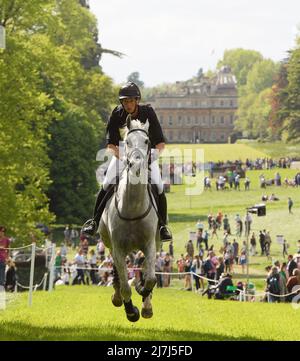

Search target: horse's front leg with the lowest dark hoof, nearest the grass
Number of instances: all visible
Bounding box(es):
[113,252,140,322]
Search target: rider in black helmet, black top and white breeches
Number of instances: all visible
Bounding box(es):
[82,82,172,241]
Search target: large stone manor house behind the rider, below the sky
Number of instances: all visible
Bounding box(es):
[152,66,238,143]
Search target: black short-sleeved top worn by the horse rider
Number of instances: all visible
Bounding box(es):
[106,105,165,148]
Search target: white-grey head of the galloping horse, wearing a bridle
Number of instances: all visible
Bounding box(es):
[125,118,151,177]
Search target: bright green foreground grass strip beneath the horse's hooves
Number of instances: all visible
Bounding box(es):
[0,286,300,341]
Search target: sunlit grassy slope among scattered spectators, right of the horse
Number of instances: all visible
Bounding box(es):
[167,169,300,270]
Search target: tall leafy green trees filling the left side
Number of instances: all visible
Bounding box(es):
[0,0,116,243]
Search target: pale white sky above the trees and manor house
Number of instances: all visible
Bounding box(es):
[90,0,300,87]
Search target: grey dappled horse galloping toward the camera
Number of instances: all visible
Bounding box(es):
[99,119,160,322]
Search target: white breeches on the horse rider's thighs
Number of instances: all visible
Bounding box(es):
[102,156,164,194]
